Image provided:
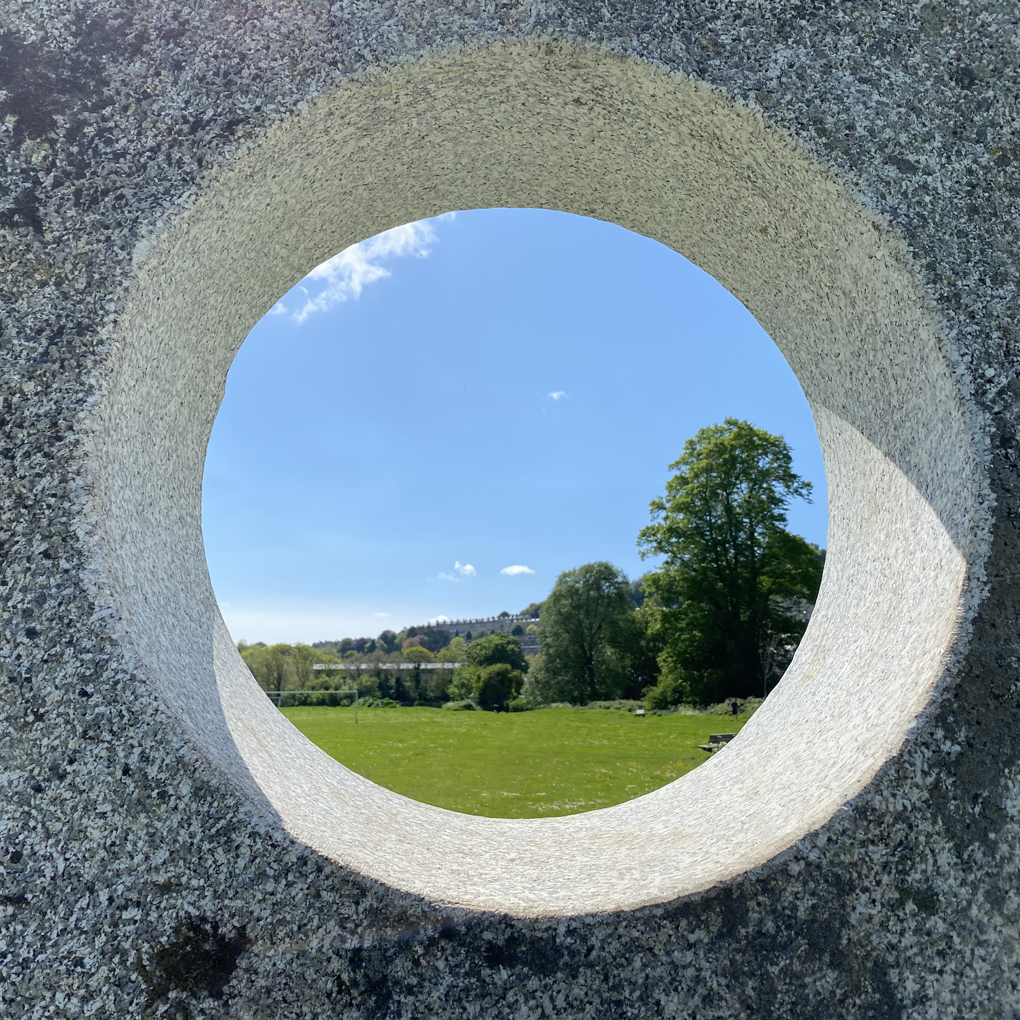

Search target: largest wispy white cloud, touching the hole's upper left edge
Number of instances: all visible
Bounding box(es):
[295,219,436,322]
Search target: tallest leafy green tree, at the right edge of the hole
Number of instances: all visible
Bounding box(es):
[638,418,823,705]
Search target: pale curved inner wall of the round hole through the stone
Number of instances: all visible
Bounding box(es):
[95,44,979,916]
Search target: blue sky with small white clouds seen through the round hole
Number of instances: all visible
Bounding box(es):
[203,209,826,642]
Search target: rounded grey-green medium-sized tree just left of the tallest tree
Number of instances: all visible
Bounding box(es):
[532,562,635,704]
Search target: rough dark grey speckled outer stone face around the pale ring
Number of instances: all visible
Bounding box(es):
[0,0,1020,1020]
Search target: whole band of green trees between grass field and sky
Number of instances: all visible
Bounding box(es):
[241,418,824,708]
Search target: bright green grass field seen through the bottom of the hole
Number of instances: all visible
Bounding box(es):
[283,707,747,818]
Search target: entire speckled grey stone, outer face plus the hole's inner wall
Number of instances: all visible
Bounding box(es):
[0,0,1020,1020]
